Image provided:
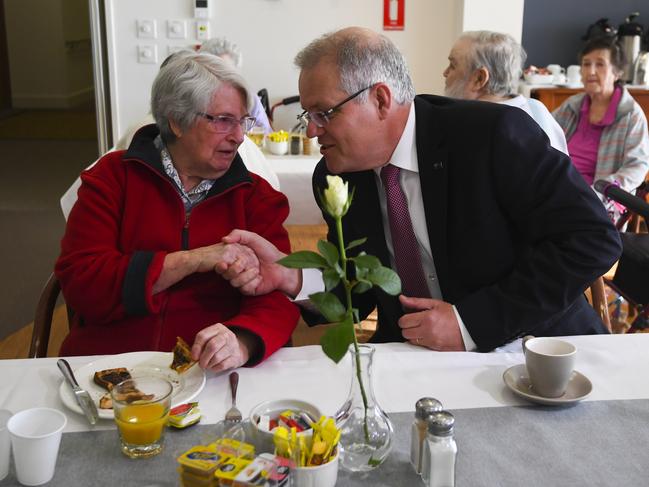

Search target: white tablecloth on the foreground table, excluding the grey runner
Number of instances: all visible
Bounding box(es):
[0,334,649,432]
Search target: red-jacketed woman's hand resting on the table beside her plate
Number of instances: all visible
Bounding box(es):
[192,323,250,372]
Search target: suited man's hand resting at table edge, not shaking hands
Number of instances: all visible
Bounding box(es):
[399,294,465,351]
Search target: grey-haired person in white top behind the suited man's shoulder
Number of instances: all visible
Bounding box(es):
[443,30,568,154]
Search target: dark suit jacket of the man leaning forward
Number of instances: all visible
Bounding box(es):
[306,95,621,351]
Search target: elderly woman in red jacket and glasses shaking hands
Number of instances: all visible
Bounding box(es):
[55,53,299,370]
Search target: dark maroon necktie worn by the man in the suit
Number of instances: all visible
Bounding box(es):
[381,164,430,298]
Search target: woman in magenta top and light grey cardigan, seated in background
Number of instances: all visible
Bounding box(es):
[552,37,649,221]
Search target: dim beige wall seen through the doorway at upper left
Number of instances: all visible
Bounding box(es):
[4,0,93,108]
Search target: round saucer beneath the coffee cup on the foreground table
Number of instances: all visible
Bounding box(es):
[503,364,593,406]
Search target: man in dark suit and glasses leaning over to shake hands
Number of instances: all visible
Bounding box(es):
[220,27,621,351]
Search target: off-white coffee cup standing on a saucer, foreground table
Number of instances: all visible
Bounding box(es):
[523,336,577,397]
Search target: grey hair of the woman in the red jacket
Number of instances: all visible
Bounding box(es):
[151,51,252,143]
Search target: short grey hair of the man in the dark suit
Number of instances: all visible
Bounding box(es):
[295,28,415,105]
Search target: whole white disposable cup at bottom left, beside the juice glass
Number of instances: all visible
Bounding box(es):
[7,408,68,485]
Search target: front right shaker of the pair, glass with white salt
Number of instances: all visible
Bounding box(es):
[421,411,457,487]
